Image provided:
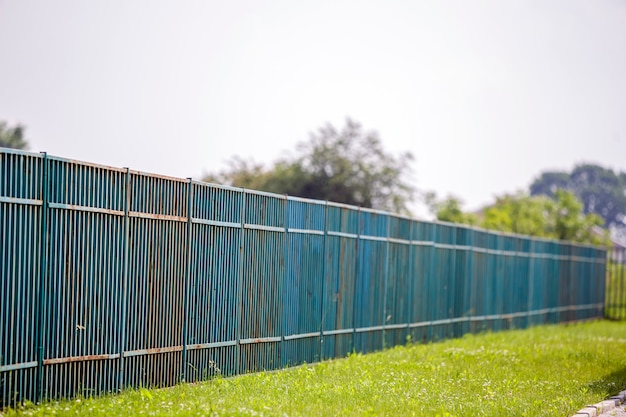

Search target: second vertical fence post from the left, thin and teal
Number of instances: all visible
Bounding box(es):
[117,168,130,391]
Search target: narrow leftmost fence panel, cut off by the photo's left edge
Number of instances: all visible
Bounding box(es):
[0,149,45,405]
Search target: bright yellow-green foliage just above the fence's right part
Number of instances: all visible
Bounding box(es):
[429,190,607,245]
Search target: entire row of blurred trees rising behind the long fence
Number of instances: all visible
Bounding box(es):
[7,115,626,244]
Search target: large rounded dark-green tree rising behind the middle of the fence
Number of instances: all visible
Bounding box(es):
[205,119,415,213]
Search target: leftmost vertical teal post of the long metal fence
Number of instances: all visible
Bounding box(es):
[35,152,49,402]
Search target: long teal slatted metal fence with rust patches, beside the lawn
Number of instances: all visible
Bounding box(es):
[0,149,606,405]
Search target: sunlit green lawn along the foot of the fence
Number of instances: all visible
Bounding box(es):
[5,321,626,417]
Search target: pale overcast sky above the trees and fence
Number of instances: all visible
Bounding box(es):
[0,0,626,218]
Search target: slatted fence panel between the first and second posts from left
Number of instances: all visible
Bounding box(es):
[39,157,126,398]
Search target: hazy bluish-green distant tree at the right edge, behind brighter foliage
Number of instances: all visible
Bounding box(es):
[530,164,626,228]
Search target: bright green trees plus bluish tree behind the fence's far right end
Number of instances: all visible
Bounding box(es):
[426,164,626,244]
